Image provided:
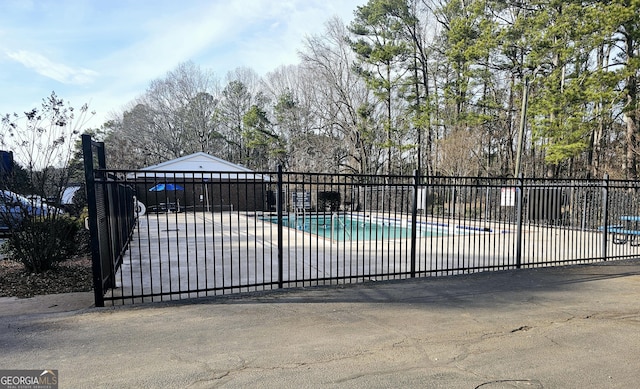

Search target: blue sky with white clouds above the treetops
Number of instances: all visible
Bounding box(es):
[0,0,367,128]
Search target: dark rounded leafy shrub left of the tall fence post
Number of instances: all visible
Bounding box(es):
[2,215,80,273]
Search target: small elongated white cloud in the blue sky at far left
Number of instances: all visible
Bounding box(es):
[7,50,98,85]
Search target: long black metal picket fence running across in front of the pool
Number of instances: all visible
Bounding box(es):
[85,160,640,305]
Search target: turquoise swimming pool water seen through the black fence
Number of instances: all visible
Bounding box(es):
[265,214,446,241]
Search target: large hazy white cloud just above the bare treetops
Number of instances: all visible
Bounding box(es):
[100,0,364,80]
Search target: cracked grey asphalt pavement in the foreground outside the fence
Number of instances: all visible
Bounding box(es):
[0,260,640,388]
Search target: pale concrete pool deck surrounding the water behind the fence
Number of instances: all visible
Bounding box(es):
[107,212,640,304]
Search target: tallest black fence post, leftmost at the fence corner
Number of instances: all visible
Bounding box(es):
[82,134,104,307]
